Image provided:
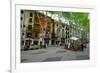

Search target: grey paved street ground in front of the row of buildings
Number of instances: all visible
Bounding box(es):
[21,46,89,63]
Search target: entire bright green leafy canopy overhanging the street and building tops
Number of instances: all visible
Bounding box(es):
[45,11,90,32]
